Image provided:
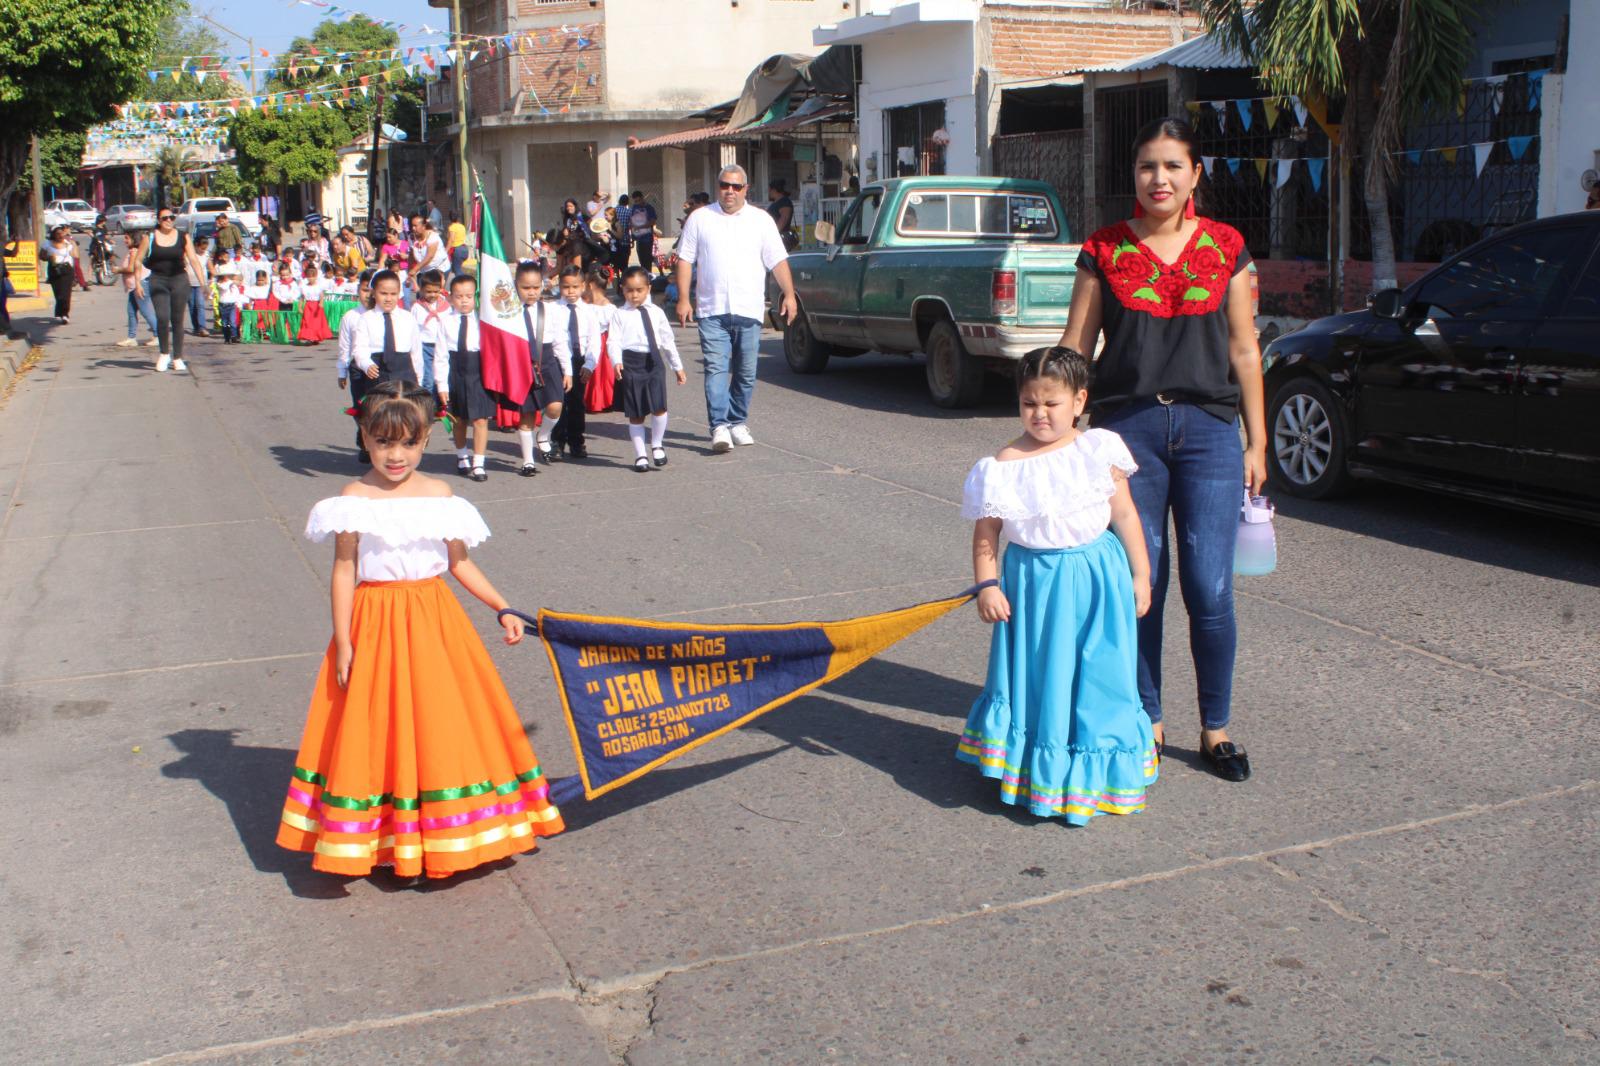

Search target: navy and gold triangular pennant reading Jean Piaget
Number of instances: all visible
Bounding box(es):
[538,589,976,799]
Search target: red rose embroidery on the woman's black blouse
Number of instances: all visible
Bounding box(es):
[1083,219,1245,319]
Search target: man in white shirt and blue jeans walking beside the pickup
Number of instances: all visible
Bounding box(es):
[677,166,798,453]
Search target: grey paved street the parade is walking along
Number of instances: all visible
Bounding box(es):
[0,281,1600,1066]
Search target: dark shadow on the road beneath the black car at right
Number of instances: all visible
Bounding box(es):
[1267,482,1600,586]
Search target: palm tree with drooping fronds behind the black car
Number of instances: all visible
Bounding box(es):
[1198,0,1482,290]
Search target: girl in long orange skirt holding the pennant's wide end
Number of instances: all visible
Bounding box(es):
[278,381,563,877]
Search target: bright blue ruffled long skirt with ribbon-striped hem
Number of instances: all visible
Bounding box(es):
[955,530,1157,826]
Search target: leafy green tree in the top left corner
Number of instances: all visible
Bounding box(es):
[0,0,168,235]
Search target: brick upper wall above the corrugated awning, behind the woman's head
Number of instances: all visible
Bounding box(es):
[984,3,1203,78]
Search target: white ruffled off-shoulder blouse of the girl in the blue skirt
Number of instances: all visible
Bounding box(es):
[962,429,1139,549]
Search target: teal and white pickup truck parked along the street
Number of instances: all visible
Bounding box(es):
[771,178,1078,407]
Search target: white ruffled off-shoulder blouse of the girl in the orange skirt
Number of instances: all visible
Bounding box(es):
[306,496,490,581]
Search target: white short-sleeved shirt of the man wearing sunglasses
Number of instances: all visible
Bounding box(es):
[678,203,789,320]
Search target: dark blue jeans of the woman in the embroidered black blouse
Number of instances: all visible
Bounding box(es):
[1094,400,1245,730]
